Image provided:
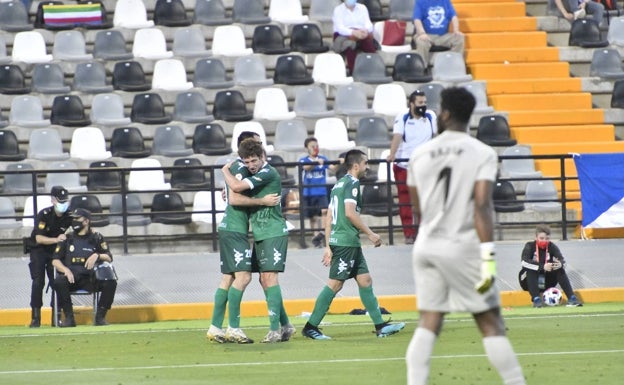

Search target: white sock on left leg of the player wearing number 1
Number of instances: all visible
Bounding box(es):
[405,327,436,385]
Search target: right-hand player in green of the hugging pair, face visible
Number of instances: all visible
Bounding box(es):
[223,139,295,343]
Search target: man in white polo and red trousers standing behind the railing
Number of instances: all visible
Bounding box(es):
[386,90,438,245]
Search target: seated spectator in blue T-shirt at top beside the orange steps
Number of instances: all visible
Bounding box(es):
[412,0,464,64]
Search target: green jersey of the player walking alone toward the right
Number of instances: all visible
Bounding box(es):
[329,174,362,247]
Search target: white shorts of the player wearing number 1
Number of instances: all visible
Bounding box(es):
[412,238,500,314]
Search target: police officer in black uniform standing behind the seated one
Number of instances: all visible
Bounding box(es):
[28,186,71,328]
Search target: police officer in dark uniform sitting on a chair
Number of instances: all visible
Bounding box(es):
[52,208,117,327]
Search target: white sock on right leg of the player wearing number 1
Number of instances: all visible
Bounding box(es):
[483,336,525,385]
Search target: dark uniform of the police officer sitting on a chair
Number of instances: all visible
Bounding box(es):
[52,231,117,317]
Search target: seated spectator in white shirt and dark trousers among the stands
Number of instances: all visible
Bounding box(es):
[332,0,378,73]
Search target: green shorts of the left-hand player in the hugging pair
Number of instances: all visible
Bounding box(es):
[219,231,251,274]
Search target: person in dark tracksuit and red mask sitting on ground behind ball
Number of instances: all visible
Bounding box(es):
[521,225,583,307]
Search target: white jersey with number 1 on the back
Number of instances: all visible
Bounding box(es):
[407,130,497,243]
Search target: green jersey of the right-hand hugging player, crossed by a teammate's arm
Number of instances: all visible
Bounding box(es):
[244,163,288,241]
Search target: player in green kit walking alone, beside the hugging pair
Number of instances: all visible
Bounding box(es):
[301,150,405,340]
